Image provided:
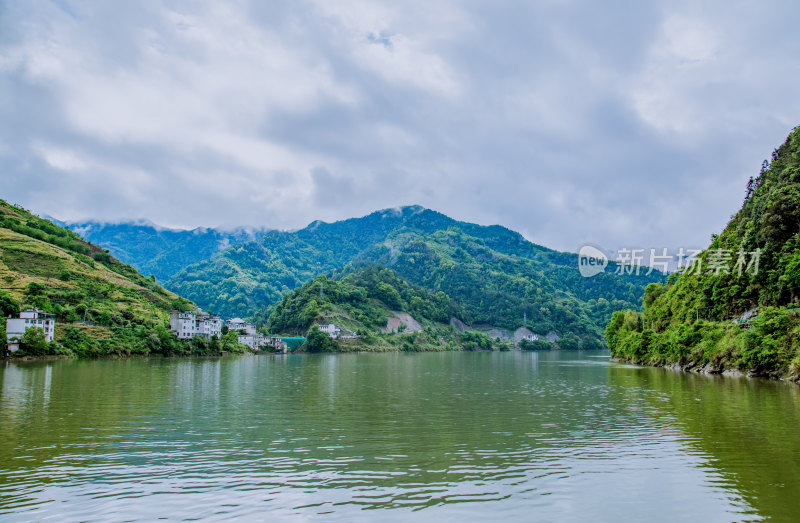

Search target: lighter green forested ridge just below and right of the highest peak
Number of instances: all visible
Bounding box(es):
[356,227,661,337]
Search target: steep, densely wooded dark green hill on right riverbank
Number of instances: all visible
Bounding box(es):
[606,127,800,376]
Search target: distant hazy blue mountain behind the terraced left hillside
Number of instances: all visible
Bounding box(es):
[59,218,267,283]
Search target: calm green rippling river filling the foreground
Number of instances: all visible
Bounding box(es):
[0,352,800,522]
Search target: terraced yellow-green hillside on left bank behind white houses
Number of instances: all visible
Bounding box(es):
[0,200,247,356]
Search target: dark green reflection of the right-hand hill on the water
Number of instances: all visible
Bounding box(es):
[609,368,800,521]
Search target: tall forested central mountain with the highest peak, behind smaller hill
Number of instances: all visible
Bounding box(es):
[167,206,663,338]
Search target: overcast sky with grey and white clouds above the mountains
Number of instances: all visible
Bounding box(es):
[0,0,800,251]
